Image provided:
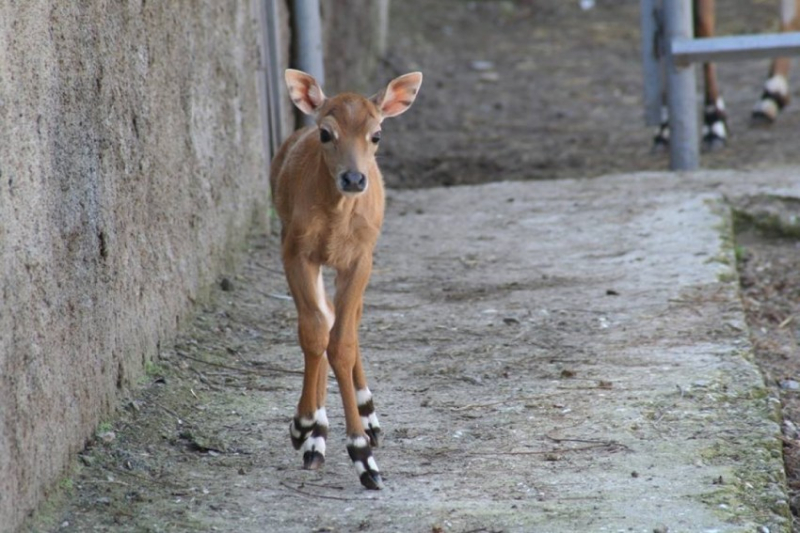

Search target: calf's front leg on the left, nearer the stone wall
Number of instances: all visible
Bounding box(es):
[284,254,332,470]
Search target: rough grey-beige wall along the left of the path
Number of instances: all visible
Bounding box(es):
[0,0,268,532]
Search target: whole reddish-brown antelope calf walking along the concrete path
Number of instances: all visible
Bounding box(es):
[270,69,422,489]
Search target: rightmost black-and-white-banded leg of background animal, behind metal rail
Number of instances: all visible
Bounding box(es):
[753,0,800,124]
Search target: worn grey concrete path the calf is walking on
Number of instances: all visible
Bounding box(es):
[28,170,790,533]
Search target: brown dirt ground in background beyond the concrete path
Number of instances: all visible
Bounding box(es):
[382,0,800,187]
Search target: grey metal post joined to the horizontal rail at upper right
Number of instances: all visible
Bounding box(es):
[663,0,700,170]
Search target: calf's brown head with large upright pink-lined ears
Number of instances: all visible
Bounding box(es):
[285,69,422,196]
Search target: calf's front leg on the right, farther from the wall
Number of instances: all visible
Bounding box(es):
[328,255,383,489]
